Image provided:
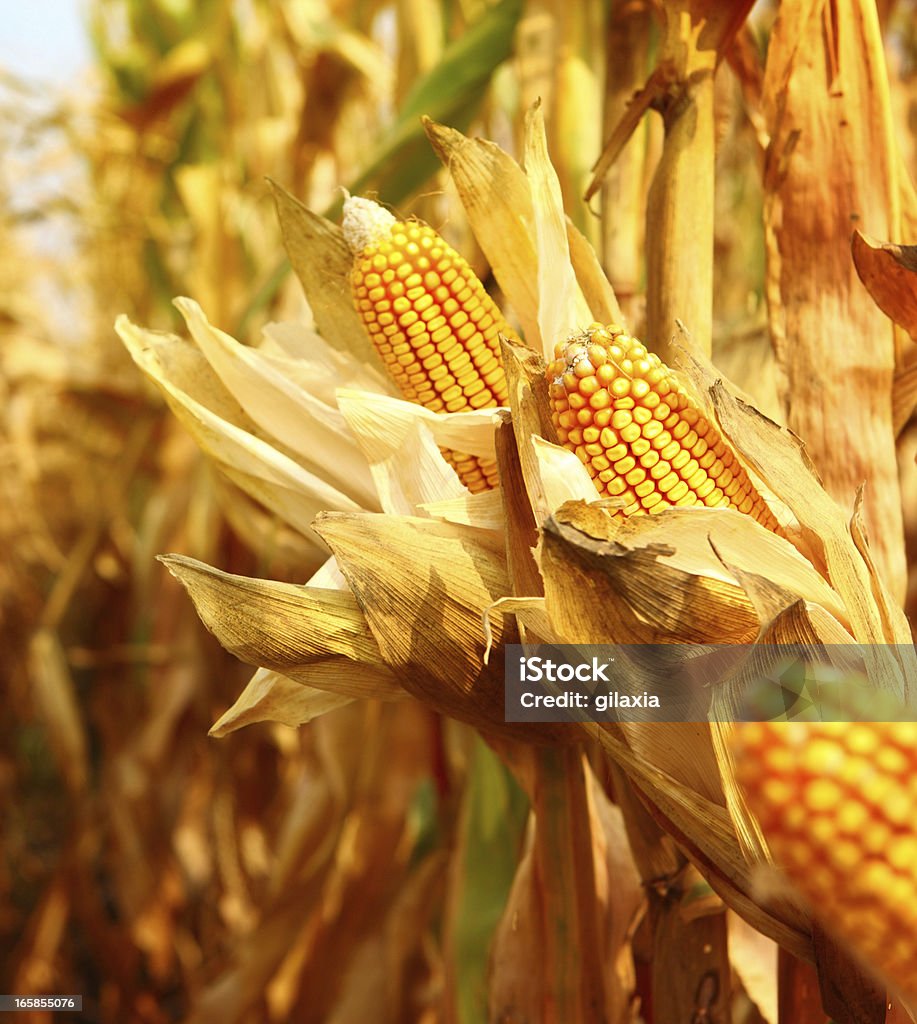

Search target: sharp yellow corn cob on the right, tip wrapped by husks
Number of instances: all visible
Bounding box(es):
[548,324,778,530]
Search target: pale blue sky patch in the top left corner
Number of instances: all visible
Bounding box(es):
[0,0,90,85]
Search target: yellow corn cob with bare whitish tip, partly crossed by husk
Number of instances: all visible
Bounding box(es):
[343,197,515,493]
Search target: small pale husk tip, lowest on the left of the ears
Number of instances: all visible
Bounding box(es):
[209,669,354,738]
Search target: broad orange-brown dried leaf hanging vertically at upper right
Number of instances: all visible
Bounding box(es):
[763,2,906,601]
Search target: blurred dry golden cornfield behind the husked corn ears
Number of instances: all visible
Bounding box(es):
[0,0,917,1024]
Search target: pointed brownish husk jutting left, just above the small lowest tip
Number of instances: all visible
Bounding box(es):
[161,555,403,700]
